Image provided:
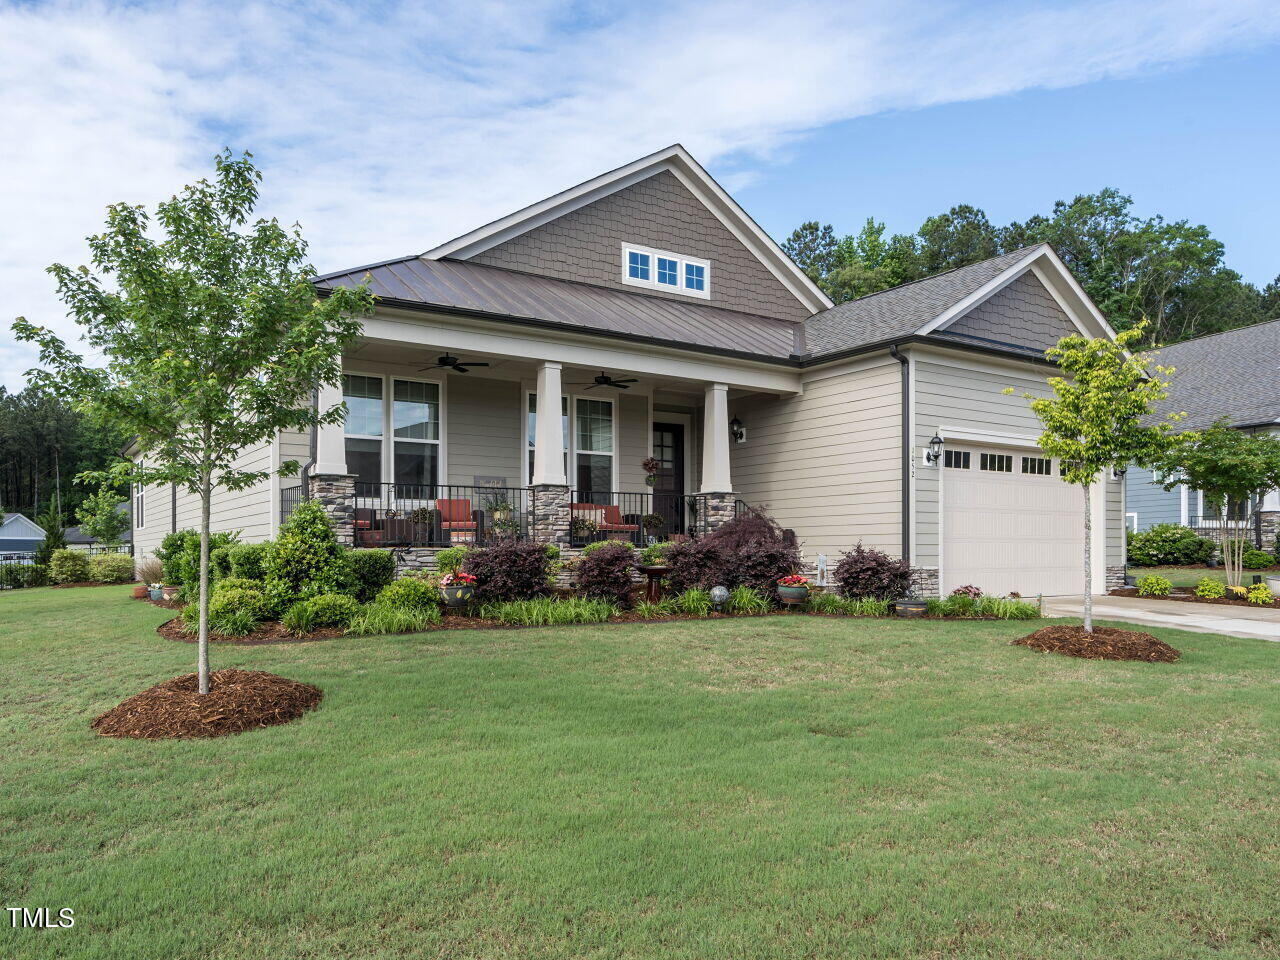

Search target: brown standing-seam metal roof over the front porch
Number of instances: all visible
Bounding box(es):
[316,256,799,358]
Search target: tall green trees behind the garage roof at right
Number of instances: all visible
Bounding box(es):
[782,187,1280,344]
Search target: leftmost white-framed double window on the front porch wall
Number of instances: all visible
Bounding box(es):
[342,374,443,495]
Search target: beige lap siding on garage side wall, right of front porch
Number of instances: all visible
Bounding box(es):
[730,357,901,561]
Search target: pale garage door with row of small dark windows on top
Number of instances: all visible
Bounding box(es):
[942,445,1084,596]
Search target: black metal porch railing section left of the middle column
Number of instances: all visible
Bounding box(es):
[355,481,532,547]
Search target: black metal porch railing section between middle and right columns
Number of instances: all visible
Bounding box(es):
[570,490,746,547]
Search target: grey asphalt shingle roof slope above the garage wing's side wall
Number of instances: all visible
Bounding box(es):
[804,247,1034,355]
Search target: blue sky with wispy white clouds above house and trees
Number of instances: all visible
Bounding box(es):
[0,0,1280,389]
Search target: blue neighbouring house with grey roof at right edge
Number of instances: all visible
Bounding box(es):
[1125,320,1280,549]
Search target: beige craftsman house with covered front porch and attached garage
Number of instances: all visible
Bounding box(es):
[134,145,1124,595]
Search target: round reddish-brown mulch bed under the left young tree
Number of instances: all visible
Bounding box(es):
[90,668,324,740]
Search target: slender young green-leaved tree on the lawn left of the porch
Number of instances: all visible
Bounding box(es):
[14,151,372,694]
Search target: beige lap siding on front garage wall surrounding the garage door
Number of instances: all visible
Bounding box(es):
[913,351,1124,567]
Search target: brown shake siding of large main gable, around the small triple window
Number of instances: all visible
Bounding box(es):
[468,170,810,320]
